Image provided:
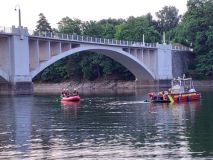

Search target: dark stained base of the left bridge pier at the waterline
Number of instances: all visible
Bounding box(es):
[0,82,33,95]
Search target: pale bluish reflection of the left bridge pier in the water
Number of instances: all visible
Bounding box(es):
[0,96,32,157]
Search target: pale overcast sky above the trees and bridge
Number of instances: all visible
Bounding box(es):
[0,0,187,30]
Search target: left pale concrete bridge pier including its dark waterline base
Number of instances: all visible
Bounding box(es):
[0,26,33,95]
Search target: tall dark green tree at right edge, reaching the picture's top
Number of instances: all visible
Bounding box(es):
[176,0,213,78]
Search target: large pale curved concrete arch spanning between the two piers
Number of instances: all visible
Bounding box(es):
[30,44,155,80]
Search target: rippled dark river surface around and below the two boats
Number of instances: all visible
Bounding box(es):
[0,90,213,160]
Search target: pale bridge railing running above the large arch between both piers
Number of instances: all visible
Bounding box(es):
[28,31,157,48]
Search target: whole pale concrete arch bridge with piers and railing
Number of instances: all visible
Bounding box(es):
[0,26,190,94]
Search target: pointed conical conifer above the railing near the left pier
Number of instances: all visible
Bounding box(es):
[36,13,52,32]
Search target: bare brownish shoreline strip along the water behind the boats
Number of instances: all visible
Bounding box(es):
[33,80,213,93]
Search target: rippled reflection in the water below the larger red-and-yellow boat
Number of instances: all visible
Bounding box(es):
[147,102,200,158]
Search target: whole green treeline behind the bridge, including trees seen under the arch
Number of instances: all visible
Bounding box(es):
[34,0,213,82]
